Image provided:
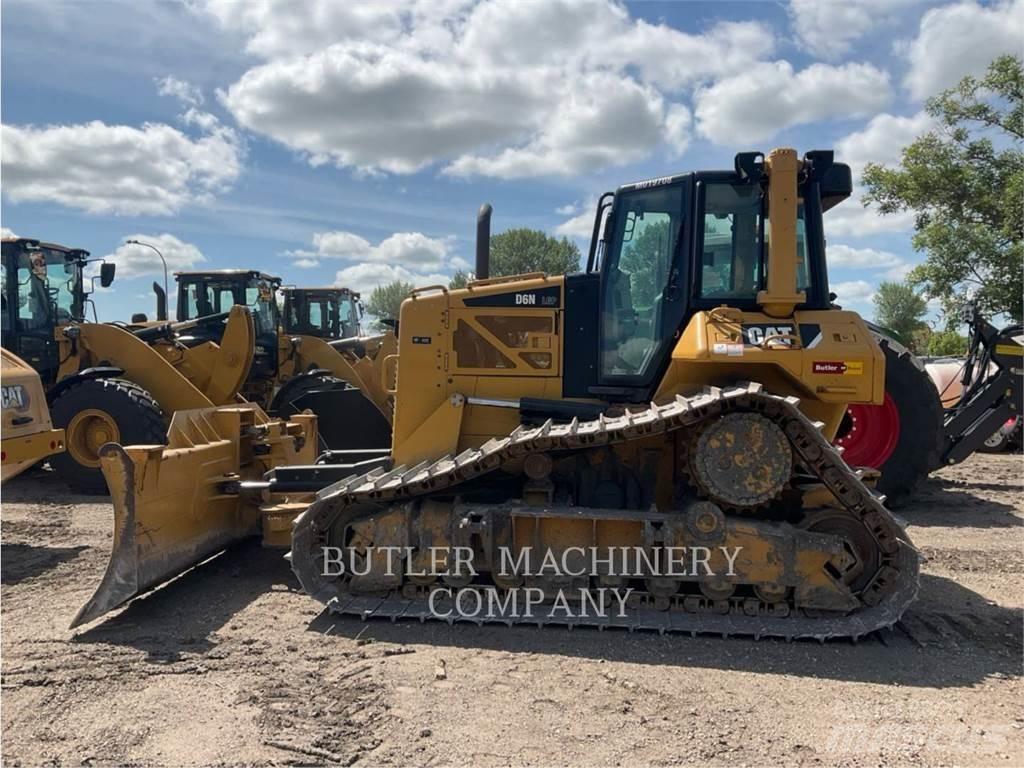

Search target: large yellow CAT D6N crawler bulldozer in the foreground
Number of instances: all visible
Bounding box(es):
[76,150,920,640]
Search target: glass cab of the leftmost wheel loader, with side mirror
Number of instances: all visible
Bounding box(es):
[0,238,103,386]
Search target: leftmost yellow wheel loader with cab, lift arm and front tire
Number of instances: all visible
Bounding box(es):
[0,238,264,494]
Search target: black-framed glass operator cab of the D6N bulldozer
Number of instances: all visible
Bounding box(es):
[563,152,851,402]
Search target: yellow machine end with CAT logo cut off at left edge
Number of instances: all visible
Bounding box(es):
[0,349,65,482]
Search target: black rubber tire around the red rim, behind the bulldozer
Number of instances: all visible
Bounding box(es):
[874,333,943,507]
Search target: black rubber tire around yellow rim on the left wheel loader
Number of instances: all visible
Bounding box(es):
[50,379,167,495]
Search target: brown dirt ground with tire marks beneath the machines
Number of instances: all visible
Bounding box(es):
[0,455,1024,766]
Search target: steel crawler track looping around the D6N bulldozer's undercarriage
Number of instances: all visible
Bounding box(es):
[291,383,920,641]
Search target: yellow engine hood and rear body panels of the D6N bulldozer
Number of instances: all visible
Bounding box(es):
[393,284,885,464]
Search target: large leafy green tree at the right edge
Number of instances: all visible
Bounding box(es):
[863,56,1024,324]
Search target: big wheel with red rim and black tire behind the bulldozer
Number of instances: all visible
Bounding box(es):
[836,333,943,507]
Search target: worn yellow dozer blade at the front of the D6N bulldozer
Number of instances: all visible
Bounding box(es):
[71,403,316,628]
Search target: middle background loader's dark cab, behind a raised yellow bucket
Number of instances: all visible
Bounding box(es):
[174,269,281,380]
